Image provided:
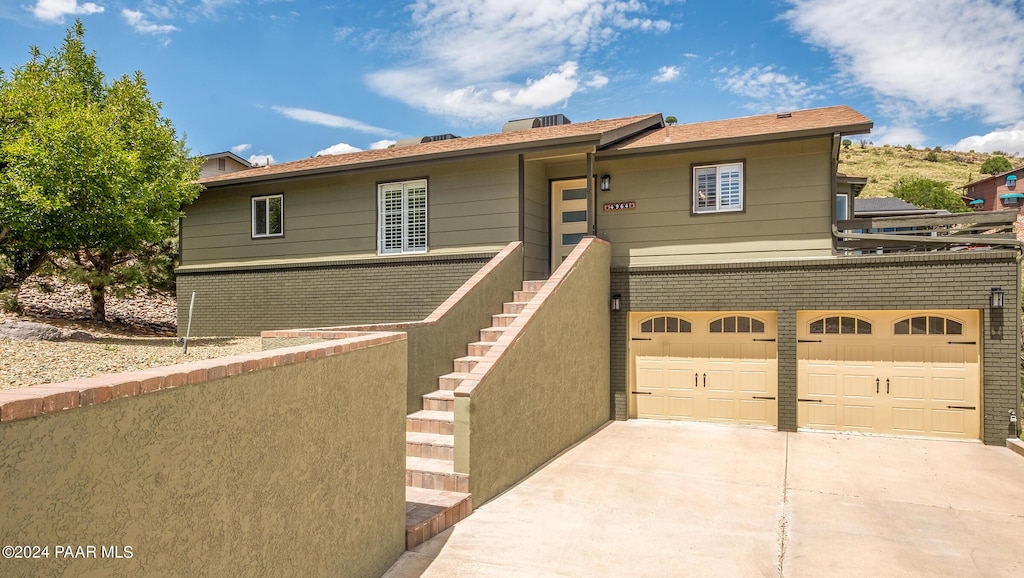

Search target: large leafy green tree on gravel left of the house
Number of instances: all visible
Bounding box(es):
[0,20,202,320]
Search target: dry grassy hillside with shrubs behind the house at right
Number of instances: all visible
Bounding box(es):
[839,142,1024,197]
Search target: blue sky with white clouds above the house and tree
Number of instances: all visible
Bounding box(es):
[0,0,1024,163]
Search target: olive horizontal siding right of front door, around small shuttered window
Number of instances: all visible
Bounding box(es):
[597,137,834,266]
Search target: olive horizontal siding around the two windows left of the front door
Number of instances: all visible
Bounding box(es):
[181,155,519,271]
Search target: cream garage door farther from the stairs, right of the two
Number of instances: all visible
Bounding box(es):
[797,311,981,439]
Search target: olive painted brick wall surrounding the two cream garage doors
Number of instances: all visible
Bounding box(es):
[611,251,1021,444]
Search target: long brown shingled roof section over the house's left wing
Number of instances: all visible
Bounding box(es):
[200,114,662,187]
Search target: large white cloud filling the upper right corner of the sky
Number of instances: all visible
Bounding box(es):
[782,0,1024,124]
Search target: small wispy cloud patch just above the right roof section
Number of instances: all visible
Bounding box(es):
[716,66,820,113]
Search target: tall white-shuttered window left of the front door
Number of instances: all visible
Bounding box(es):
[377,180,427,255]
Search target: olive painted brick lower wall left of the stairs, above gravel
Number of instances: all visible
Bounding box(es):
[177,254,494,335]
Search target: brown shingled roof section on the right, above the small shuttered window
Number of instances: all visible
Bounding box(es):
[608,106,872,152]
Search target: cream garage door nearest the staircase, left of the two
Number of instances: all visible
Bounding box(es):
[630,312,778,425]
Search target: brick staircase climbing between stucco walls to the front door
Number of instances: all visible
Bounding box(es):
[406,281,545,548]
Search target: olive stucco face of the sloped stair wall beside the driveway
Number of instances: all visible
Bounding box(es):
[456,239,611,505]
